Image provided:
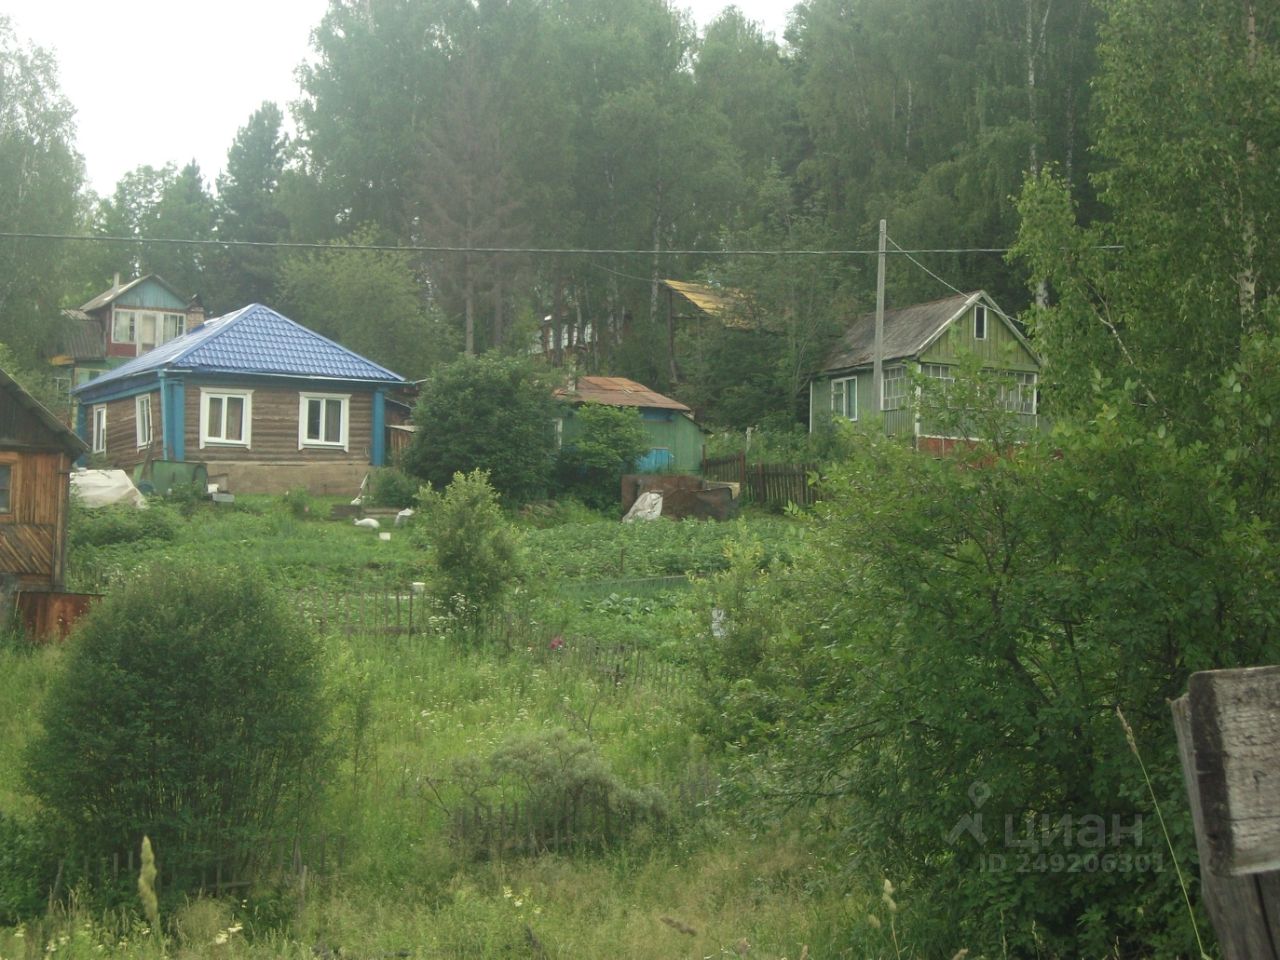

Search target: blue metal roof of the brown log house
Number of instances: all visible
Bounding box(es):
[76,303,406,397]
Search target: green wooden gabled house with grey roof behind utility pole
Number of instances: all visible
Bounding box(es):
[809,291,1041,449]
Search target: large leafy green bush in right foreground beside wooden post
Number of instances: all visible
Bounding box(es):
[700,407,1280,956]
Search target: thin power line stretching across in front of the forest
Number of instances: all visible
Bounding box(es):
[0,230,1124,259]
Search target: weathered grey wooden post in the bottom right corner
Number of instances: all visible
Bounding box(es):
[1170,667,1280,960]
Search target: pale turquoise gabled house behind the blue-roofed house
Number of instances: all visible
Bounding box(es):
[50,274,205,387]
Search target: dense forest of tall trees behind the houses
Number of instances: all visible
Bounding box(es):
[0,0,1101,426]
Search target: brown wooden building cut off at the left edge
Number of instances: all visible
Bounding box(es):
[0,370,84,623]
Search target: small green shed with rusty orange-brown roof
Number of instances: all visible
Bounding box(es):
[556,376,703,474]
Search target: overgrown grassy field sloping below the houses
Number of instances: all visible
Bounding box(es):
[0,499,909,960]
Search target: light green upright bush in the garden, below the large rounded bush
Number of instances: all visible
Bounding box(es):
[415,470,522,622]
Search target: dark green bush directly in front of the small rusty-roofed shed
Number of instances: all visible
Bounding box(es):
[556,403,649,509]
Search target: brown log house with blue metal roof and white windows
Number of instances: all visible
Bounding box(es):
[74,303,408,493]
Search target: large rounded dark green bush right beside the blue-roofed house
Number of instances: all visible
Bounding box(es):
[403,356,556,503]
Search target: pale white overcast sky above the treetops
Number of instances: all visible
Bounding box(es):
[0,0,795,195]
